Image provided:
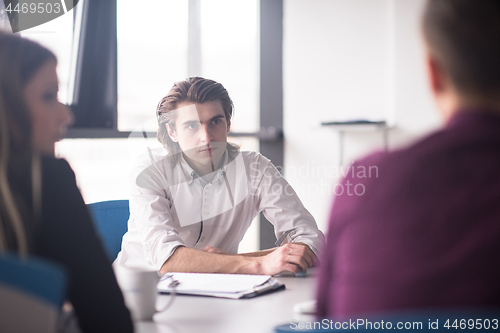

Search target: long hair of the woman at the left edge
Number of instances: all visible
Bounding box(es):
[0,31,56,255]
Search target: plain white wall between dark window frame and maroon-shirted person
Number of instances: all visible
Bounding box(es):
[283,0,440,230]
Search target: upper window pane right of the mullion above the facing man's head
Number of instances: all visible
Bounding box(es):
[201,0,260,132]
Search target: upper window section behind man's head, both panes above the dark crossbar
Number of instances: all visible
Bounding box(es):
[117,0,259,136]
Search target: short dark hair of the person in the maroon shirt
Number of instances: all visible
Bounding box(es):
[423,0,500,99]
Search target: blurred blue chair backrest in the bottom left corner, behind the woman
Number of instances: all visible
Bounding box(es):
[0,255,67,333]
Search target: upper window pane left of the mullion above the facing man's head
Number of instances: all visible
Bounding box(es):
[117,0,188,131]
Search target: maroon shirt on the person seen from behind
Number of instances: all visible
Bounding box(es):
[317,110,500,317]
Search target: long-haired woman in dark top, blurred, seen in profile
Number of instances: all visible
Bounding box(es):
[0,32,133,332]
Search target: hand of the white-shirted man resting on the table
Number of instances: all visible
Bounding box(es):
[257,243,317,275]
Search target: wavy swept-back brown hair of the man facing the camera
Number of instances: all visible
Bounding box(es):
[156,77,238,165]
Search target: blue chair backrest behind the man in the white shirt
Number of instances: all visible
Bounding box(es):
[87,200,130,261]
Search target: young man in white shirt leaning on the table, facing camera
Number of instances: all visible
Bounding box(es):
[115,77,324,275]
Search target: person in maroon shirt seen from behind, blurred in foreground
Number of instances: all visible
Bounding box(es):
[317,0,500,317]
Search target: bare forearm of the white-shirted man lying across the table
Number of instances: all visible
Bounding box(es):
[160,247,260,274]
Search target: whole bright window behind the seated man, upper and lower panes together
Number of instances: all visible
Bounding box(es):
[56,0,259,252]
